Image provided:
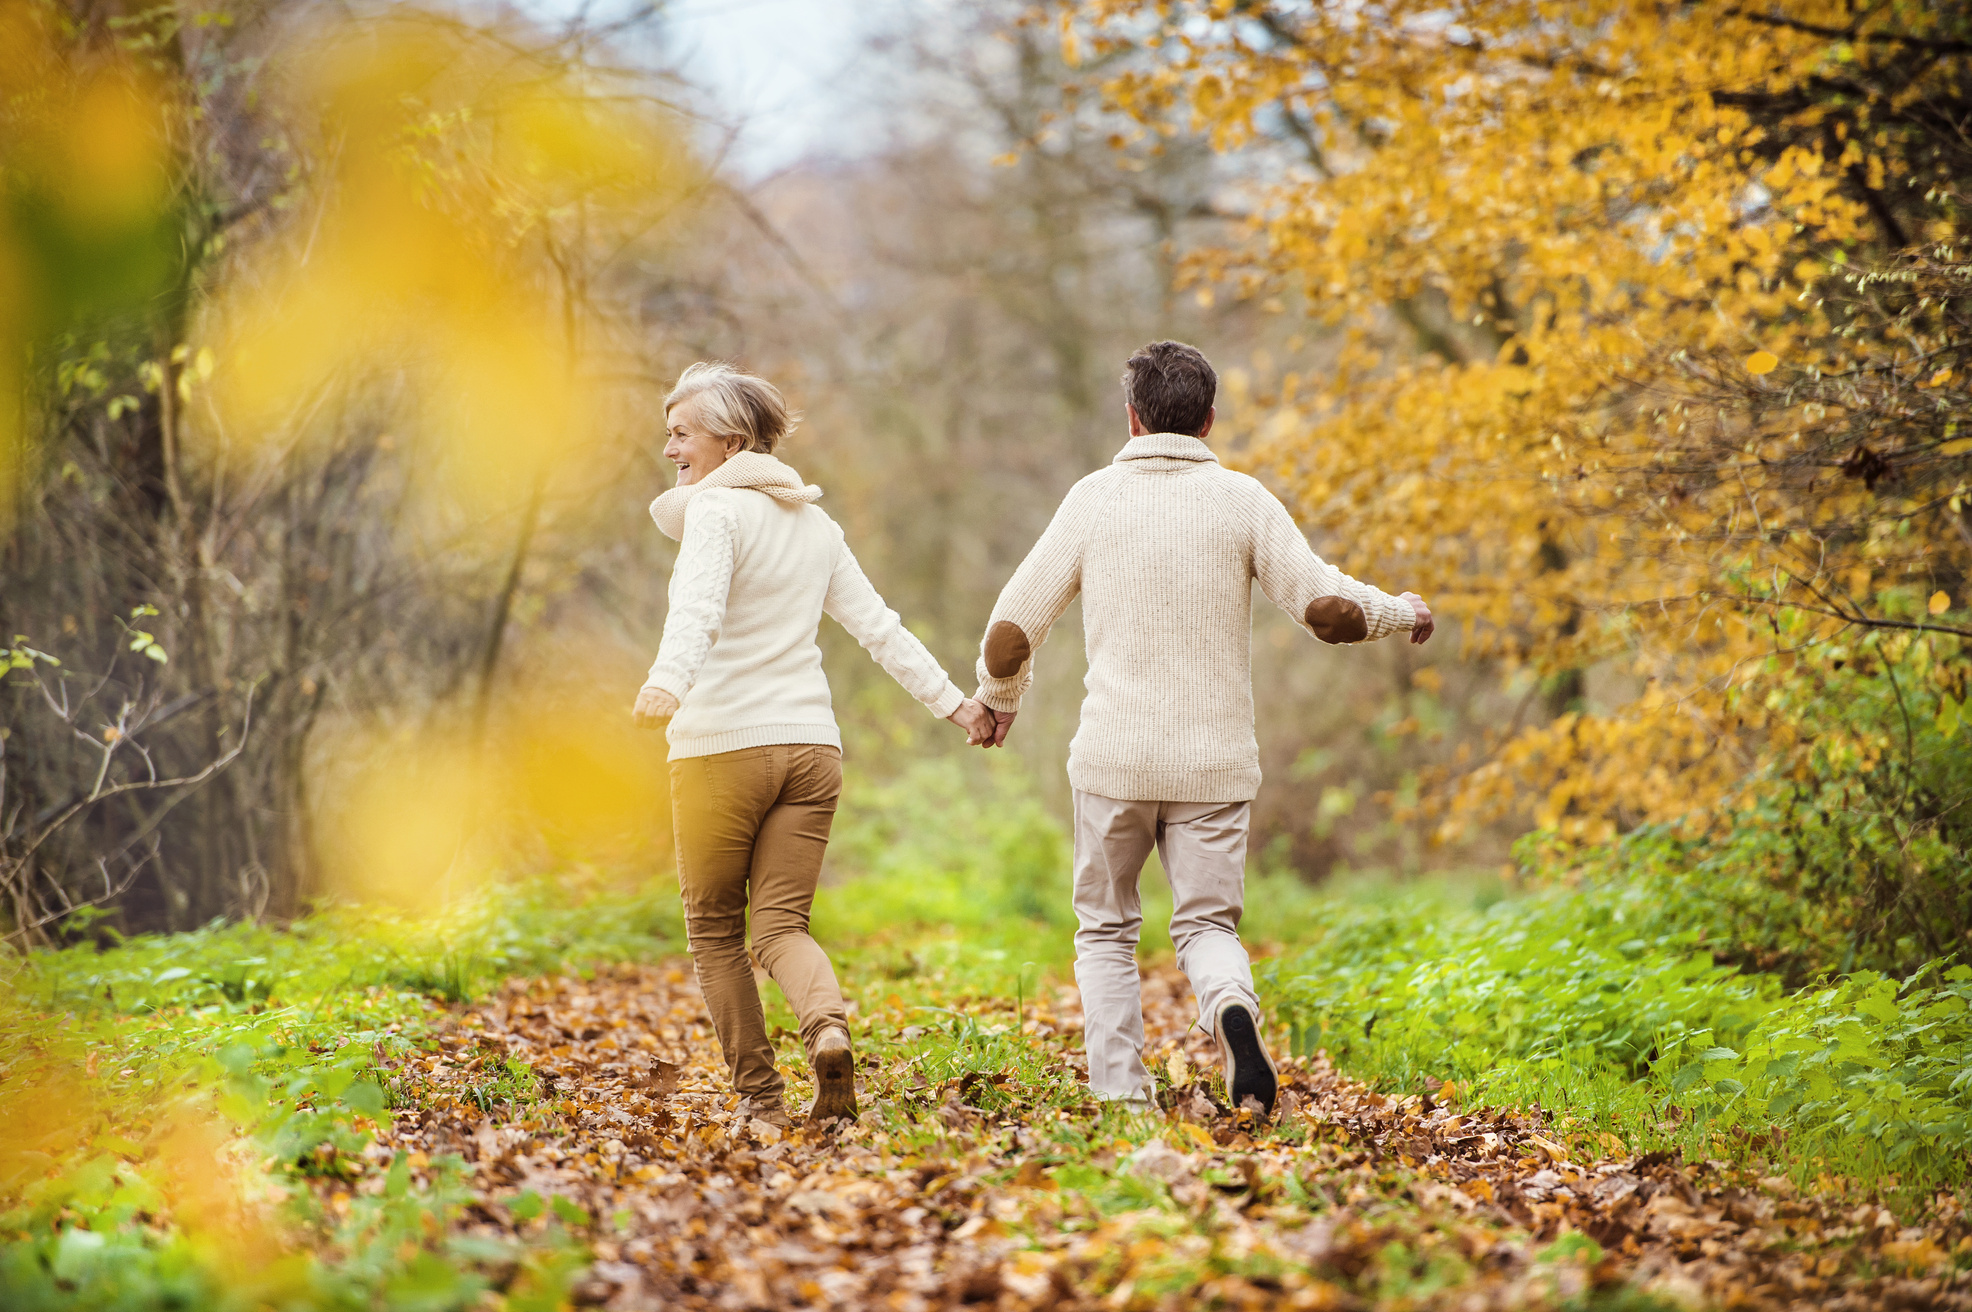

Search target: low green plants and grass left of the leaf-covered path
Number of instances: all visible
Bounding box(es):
[0,876,682,1312]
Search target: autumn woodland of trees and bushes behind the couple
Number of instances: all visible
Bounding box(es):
[0,0,1972,1302]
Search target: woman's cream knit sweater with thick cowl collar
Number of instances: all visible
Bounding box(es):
[645,452,964,762]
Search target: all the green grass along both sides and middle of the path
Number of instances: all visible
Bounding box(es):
[0,758,1972,1312]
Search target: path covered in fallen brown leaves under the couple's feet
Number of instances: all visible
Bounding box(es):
[358,961,1972,1310]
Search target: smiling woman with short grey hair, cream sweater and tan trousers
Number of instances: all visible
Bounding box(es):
[633,363,994,1127]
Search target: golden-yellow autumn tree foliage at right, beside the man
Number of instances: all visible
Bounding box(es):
[1059,0,1972,840]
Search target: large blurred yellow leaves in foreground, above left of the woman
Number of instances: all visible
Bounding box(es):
[215,21,694,511]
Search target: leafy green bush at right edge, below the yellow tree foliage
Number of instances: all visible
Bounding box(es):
[1518,631,1972,988]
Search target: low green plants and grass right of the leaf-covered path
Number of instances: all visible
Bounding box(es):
[1258,886,1972,1192]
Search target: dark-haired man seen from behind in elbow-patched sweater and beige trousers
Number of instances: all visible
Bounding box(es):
[978,341,1432,1115]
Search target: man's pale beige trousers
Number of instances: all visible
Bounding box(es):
[1075,789,1260,1099]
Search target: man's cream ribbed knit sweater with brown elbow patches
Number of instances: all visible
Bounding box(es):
[978,432,1416,801]
